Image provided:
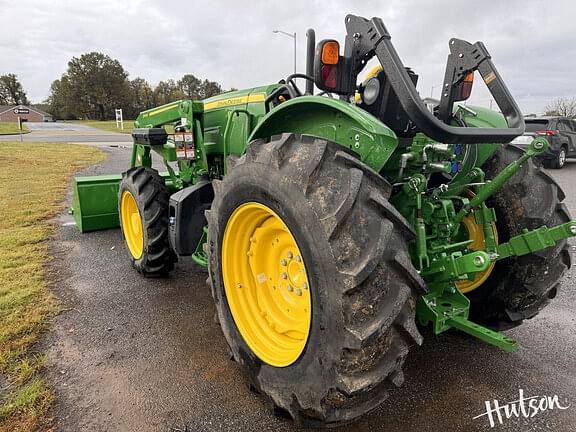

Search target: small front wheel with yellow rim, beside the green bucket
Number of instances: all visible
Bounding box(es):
[118,167,177,277]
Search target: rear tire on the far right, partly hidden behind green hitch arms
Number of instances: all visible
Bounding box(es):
[468,145,571,330]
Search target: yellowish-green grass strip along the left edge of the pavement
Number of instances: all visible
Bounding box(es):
[0,142,105,432]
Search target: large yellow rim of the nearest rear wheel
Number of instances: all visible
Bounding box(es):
[222,202,312,367]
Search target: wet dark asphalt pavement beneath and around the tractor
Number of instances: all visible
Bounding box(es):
[45,128,576,432]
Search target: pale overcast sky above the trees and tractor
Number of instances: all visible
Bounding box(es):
[0,0,576,113]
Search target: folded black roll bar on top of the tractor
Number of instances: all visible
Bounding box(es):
[341,15,525,144]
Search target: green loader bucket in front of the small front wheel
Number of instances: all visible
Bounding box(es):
[71,174,122,232]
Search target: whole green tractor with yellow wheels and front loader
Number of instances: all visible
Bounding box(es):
[73,15,576,427]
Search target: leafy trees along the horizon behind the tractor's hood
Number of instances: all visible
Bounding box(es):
[0,52,234,120]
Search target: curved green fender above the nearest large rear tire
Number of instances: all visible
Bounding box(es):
[249,96,398,172]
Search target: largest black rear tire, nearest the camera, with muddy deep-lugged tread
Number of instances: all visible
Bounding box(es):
[207,134,424,427]
